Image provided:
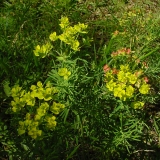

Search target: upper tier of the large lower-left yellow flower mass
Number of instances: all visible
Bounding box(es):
[11,82,58,112]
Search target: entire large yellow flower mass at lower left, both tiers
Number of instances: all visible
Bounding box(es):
[11,81,65,139]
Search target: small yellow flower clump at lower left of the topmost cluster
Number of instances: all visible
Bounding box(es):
[33,43,53,58]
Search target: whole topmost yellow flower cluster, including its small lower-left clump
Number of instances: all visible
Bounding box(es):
[33,17,87,58]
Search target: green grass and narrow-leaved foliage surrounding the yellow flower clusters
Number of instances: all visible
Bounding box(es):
[0,0,160,160]
